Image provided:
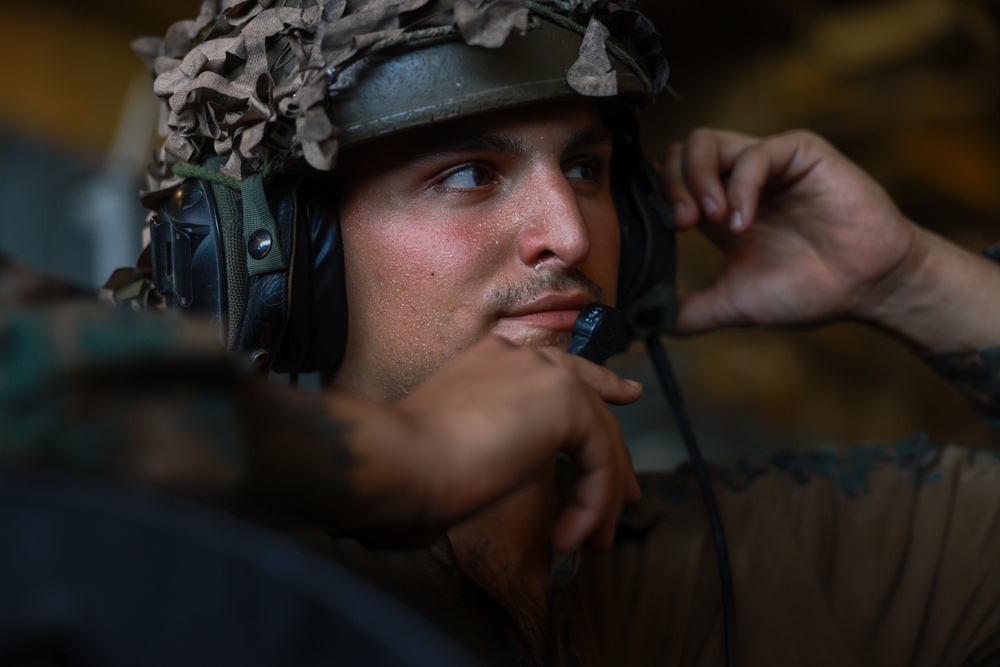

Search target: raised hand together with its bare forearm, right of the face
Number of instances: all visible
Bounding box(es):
[664,130,1000,349]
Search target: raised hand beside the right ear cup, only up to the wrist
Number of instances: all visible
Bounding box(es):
[666,130,916,332]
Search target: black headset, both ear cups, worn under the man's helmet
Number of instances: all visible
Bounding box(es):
[150,105,676,376]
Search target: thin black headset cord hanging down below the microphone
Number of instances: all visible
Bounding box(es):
[646,334,736,667]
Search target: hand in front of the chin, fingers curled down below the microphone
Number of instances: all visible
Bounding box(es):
[338,338,641,552]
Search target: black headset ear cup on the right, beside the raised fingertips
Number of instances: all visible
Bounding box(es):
[611,110,677,340]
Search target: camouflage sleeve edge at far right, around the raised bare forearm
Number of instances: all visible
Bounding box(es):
[924,243,1000,431]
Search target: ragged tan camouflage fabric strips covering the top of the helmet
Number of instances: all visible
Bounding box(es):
[133,0,667,209]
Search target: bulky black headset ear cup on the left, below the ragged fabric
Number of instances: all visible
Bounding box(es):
[150,178,347,374]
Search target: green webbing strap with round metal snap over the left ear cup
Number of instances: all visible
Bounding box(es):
[173,163,287,276]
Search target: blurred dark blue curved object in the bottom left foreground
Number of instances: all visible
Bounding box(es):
[0,472,474,667]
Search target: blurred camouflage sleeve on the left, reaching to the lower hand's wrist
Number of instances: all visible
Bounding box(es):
[0,255,357,526]
